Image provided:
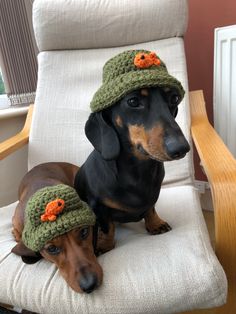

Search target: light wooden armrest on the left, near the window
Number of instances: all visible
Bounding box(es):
[0,105,34,160]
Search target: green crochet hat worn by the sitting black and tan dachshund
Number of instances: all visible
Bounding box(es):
[90,50,185,112]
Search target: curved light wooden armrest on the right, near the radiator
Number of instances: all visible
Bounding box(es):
[190,91,236,314]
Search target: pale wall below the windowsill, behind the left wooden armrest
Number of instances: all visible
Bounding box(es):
[0,115,28,206]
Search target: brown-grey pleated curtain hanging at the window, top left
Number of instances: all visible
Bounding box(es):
[0,0,37,105]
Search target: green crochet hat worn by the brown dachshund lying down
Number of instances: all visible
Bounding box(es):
[22,184,95,252]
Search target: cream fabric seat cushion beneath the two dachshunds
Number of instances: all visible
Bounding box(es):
[0,186,227,314]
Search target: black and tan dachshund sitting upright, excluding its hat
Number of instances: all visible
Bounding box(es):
[75,87,190,252]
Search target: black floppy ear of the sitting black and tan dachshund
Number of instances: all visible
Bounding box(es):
[85,112,120,160]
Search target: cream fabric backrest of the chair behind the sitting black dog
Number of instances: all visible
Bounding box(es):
[29,38,193,185]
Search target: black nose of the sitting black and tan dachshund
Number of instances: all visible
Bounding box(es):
[165,136,190,159]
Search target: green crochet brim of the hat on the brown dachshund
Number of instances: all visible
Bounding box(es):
[22,201,96,252]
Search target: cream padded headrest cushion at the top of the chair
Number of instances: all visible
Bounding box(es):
[33,0,187,51]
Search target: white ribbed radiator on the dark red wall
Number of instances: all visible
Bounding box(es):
[213,25,236,157]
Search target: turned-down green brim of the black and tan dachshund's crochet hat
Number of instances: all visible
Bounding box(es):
[90,67,185,112]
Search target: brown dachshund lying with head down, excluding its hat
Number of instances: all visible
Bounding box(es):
[12,162,103,293]
